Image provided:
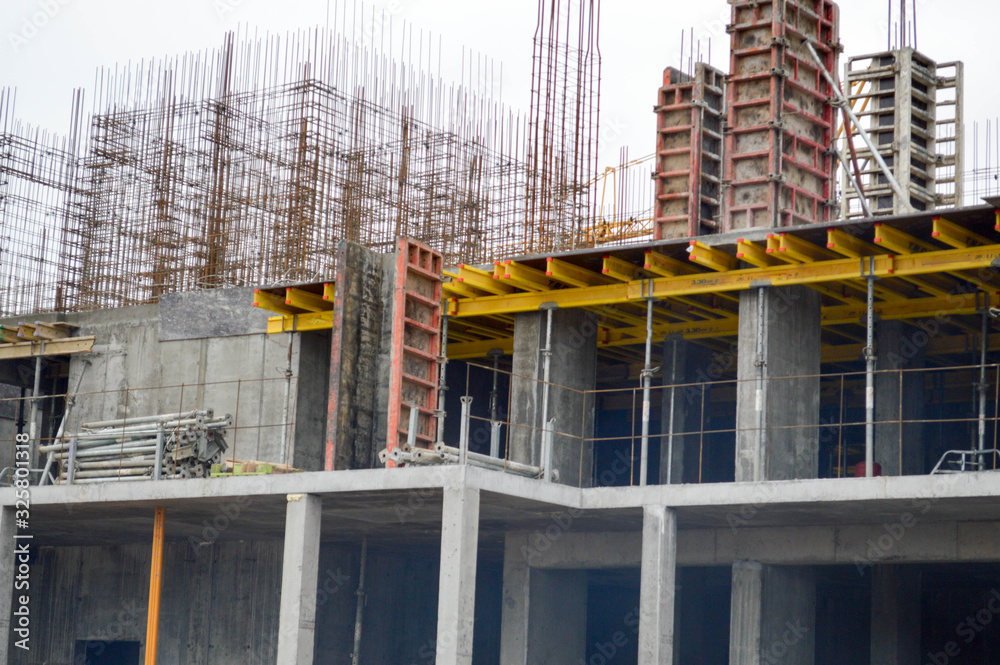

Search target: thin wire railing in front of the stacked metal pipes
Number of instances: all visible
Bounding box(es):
[0,377,296,484]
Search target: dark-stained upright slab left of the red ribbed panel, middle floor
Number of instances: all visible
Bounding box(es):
[327,243,392,470]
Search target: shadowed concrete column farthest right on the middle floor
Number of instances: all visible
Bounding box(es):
[875,321,927,476]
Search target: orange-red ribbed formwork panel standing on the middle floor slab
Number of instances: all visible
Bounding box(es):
[386,238,443,466]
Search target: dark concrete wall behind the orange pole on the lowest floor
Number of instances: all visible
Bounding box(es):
[11,541,282,665]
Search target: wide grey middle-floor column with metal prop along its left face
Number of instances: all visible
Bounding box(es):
[736,286,821,482]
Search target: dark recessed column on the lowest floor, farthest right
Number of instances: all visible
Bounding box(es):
[871,565,921,665]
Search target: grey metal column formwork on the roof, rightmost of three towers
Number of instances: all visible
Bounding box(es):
[841,52,964,219]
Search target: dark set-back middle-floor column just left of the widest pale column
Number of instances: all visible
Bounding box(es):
[660,337,719,485]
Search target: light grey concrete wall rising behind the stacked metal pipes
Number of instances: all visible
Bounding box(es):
[5,289,329,470]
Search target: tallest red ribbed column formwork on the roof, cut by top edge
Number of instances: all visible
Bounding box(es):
[724,0,841,231]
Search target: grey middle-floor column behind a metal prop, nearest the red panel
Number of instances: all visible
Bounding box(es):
[510,309,599,487]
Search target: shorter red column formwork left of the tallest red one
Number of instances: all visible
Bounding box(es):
[653,63,725,240]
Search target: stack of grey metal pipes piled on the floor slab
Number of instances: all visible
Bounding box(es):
[39,409,232,484]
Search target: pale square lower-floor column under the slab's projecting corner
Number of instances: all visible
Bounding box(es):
[435,487,479,665]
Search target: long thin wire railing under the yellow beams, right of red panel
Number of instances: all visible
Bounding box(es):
[399,362,1000,487]
